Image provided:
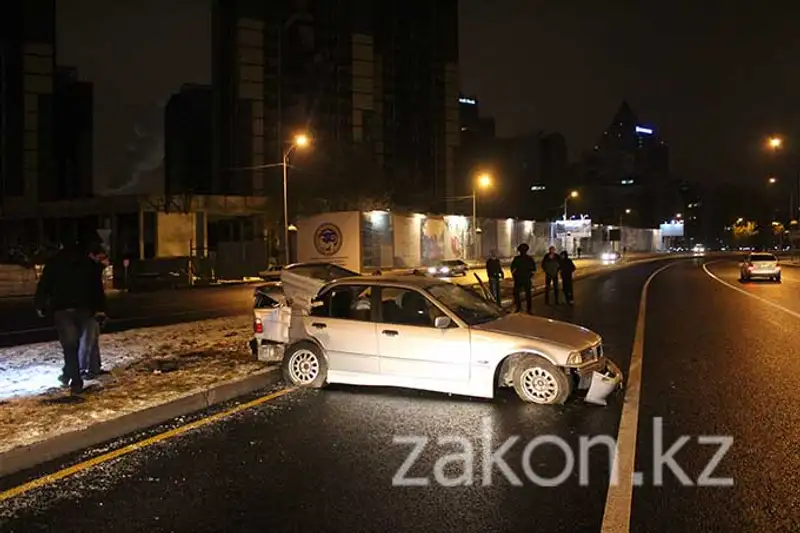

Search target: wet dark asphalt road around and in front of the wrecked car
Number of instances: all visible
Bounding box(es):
[6,258,800,532]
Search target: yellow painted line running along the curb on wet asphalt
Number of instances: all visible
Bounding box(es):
[0,388,295,503]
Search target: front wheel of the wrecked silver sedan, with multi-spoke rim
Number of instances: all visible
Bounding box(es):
[513,356,573,405]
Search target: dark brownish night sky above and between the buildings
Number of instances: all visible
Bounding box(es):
[58,0,800,190]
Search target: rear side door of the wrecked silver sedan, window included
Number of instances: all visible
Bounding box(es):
[306,284,380,375]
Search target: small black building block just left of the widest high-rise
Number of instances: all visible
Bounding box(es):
[164,84,214,196]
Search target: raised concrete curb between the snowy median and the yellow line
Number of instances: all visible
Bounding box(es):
[0,366,280,477]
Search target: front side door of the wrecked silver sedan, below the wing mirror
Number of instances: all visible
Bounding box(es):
[377,286,471,380]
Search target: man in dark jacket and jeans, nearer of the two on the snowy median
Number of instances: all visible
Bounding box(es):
[35,243,106,393]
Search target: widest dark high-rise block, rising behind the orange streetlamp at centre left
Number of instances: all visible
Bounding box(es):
[213,0,459,212]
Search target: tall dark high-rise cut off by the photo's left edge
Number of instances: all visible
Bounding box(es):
[0,0,55,209]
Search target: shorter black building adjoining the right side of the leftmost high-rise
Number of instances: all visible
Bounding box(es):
[51,67,94,201]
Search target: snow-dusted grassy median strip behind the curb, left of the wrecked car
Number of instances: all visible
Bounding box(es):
[0,316,266,452]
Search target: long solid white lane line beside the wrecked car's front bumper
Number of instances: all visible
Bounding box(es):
[601,261,684,533]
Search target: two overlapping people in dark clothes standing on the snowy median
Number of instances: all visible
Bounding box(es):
[35,242,107,393]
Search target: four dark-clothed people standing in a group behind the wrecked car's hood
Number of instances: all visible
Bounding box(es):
[486,243,575,313]
